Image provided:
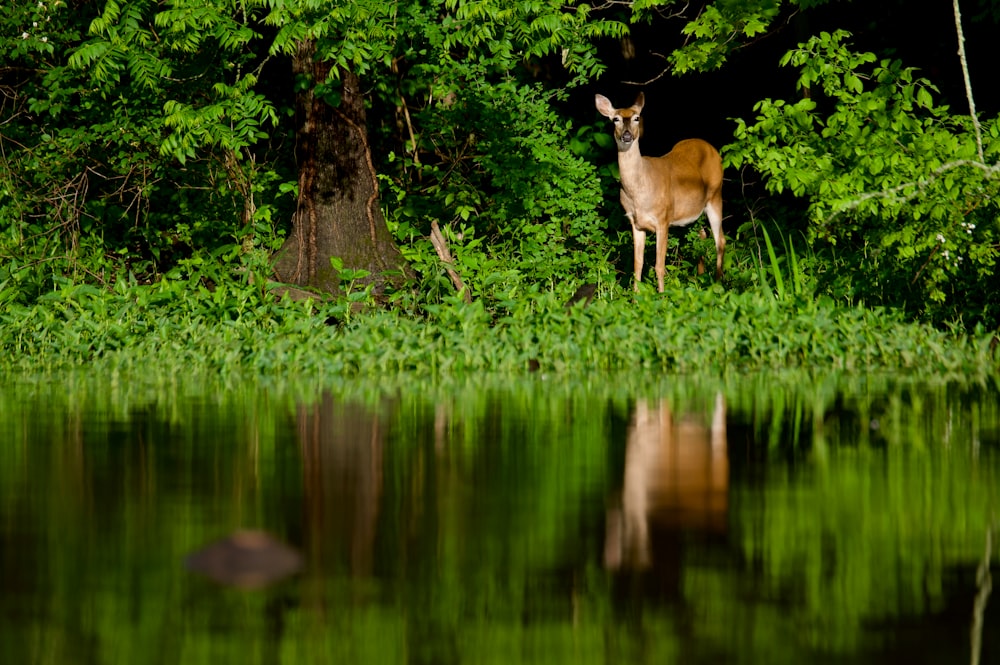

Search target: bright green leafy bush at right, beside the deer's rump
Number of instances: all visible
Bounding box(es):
[726,32,1000,326]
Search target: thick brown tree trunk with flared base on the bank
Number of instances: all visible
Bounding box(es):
[275,41,408,294]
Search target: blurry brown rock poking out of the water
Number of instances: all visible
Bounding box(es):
[184,531,302,589]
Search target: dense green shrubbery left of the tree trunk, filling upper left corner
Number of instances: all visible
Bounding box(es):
[0,1,288,294]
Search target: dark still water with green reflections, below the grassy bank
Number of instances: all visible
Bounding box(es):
[0,376,1000,665]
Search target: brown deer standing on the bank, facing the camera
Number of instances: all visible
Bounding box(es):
[595,92,726,293]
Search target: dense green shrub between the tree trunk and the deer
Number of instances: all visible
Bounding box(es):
[387,76,612,299]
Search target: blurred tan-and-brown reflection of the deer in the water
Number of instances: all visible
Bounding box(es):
[604,394,729,570]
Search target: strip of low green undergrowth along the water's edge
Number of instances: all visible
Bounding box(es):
[0,270,1000,380]
